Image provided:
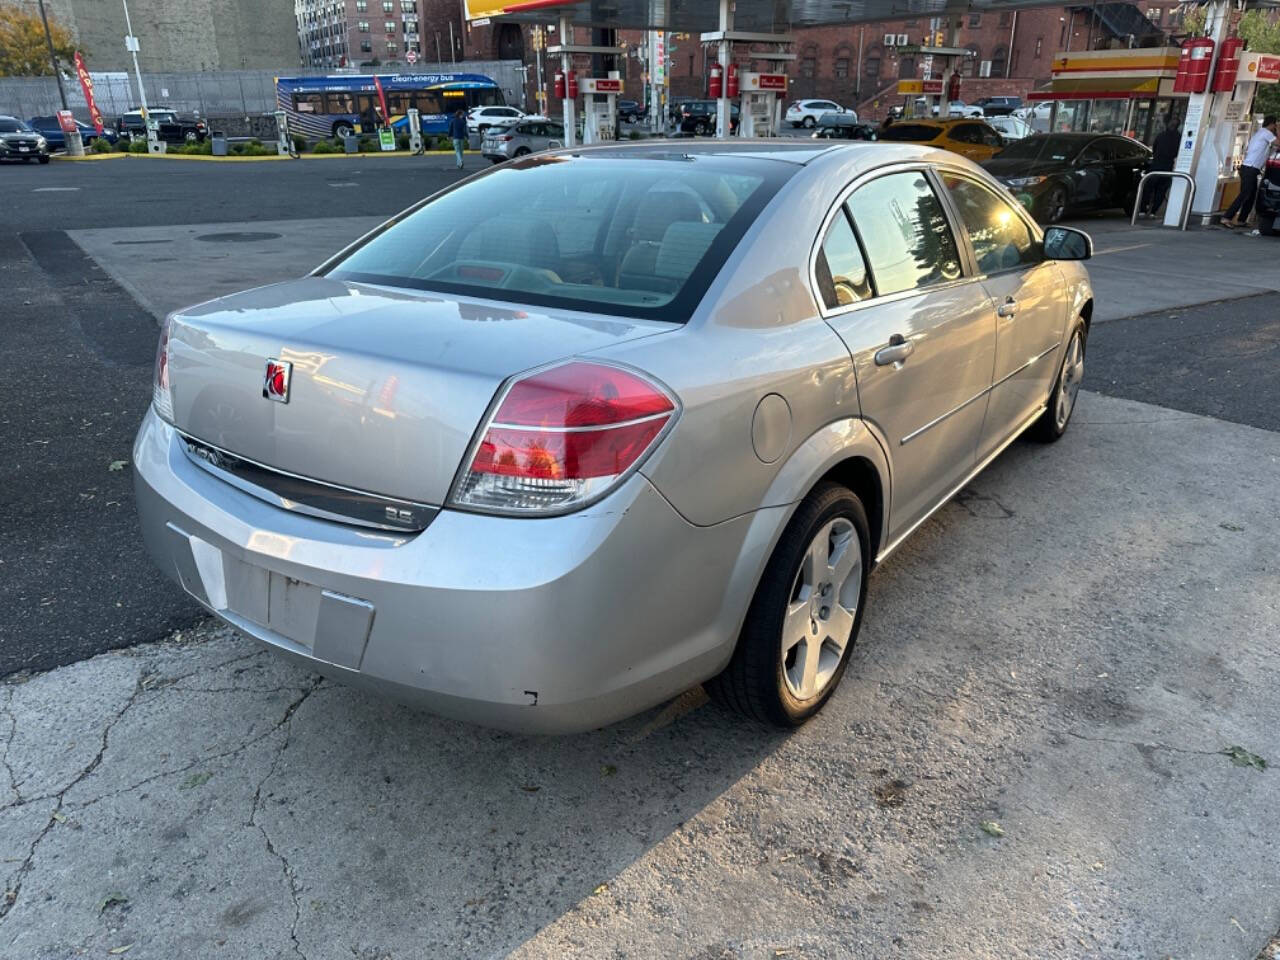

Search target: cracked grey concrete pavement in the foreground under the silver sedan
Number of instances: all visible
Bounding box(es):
[0,393,1280,960]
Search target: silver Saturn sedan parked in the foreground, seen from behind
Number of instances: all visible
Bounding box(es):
[133,141,1093,732]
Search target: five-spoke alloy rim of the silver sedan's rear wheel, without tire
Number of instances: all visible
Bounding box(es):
[781,517,863,700]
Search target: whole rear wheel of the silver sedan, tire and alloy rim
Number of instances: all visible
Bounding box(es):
[707,483,870,727]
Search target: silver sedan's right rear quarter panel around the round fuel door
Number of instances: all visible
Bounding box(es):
[591,143,919,535]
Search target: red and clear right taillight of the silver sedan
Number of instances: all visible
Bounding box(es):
[453,361,676,513]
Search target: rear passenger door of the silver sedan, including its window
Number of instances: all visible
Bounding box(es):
[814,166,996,539]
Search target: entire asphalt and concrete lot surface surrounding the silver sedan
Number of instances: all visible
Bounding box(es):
[0,157,1280,960]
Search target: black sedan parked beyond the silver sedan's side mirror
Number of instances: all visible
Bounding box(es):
[983,133,1151,223]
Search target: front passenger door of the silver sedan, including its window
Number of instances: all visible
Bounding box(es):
[940,170,1066,461]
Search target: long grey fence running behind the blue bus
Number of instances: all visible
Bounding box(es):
[0,60,525,120]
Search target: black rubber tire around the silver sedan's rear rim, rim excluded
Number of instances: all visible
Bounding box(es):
[705,481,870,727]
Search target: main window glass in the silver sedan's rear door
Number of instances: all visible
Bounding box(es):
[849,171,961,296]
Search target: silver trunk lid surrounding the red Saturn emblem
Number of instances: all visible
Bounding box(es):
[168,276,675,504]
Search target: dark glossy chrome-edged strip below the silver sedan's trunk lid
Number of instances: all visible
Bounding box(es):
[174,429,440,534]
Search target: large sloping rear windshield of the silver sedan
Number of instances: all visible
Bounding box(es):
[328,155,796,323]
